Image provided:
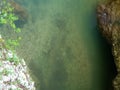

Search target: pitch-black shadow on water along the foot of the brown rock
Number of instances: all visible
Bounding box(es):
[100,36,117,90]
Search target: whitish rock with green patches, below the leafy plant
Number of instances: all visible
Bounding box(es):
[0,37,35,90]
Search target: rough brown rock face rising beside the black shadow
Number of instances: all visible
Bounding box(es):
[97,0,120,90]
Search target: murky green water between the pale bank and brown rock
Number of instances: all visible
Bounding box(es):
[1,0,114,90]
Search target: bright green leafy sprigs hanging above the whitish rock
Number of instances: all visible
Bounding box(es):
[0,0,21,51]
